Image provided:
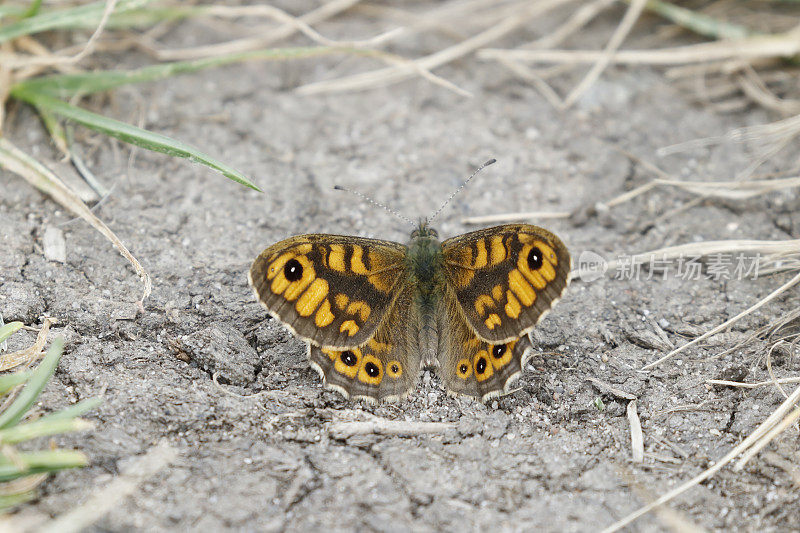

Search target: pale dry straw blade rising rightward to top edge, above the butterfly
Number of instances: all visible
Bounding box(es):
[297,0,572,95]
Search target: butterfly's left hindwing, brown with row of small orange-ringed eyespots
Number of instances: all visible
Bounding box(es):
[308,287,420,401]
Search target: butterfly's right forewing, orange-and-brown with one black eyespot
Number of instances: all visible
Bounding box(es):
[442,224,572,342]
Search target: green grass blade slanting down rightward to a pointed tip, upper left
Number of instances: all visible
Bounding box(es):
[12,87,261,192]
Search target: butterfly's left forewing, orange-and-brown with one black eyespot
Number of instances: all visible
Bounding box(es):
[249,234,406,348]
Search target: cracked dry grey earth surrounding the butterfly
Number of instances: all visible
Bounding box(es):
[0,9,800,531]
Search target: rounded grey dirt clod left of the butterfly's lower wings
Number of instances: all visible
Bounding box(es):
[178,324,259,386]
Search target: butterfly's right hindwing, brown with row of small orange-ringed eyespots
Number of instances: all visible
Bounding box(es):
[437,288,532,402]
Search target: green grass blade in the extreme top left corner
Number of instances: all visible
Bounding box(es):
[0,0,150,43]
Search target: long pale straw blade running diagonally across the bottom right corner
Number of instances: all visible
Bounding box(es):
[603,387,800,533]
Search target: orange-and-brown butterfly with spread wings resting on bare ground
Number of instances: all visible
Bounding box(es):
[249,218,572,402]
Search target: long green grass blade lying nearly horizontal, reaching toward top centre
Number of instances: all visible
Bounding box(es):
[12,46,340,99]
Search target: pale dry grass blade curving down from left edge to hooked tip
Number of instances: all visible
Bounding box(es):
[0,138,152,310]
